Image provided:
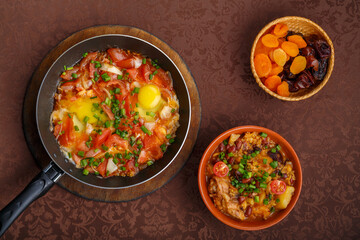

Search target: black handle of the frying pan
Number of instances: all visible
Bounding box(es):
[0,162,64,237]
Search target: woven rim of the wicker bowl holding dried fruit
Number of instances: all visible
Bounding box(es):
[250,16,335,101]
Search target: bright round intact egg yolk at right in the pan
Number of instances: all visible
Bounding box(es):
[138,84,161,109]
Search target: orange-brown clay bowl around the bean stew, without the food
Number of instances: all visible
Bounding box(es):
[198,126,302,231]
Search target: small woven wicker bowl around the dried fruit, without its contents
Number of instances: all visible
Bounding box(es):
[250,16,335,101]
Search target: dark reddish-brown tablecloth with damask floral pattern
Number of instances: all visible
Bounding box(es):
[0,0,360,239]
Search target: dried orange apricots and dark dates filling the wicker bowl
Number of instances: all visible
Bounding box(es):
[254,23,331,97]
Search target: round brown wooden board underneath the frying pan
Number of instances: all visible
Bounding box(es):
[22,25,201,202]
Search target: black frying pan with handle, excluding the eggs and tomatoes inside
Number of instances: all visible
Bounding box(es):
[0,34,191,236]
